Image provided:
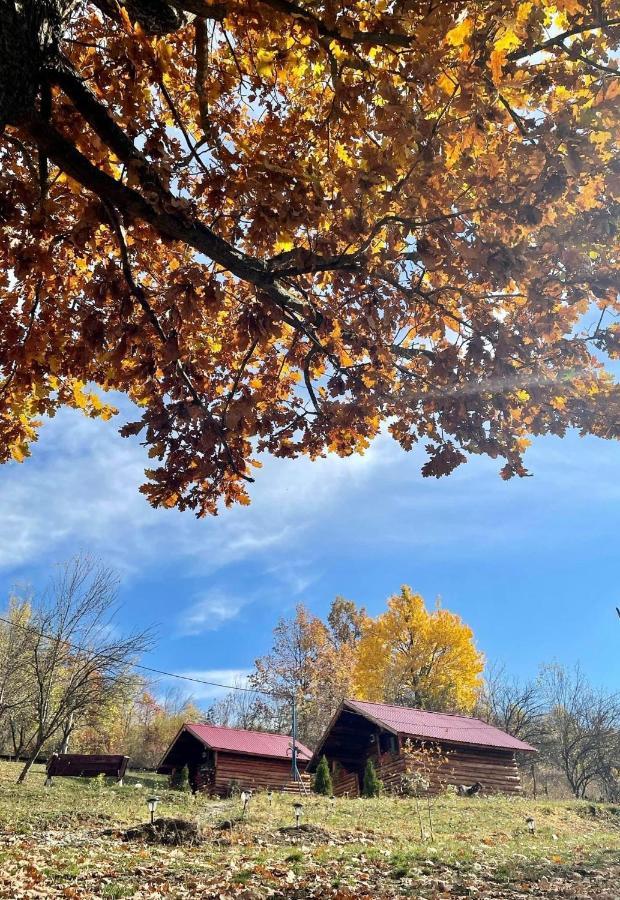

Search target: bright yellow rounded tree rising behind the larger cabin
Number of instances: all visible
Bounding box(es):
[355,585,484,712]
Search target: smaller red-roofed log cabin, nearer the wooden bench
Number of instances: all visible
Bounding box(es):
[157,723,312,797]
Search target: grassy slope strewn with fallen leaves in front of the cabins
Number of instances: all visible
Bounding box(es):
[0,763,620,900]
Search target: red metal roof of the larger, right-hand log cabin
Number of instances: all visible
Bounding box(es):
[345,700,535,752]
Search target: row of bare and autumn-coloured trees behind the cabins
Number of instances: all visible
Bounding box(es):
[0,568,620,801]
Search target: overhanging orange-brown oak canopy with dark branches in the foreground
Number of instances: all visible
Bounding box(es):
[0,0,620,514]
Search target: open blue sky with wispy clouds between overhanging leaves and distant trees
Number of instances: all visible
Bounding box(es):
[0,400,620,703]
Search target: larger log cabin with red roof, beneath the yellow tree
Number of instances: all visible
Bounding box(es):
[307,700,536,797]
